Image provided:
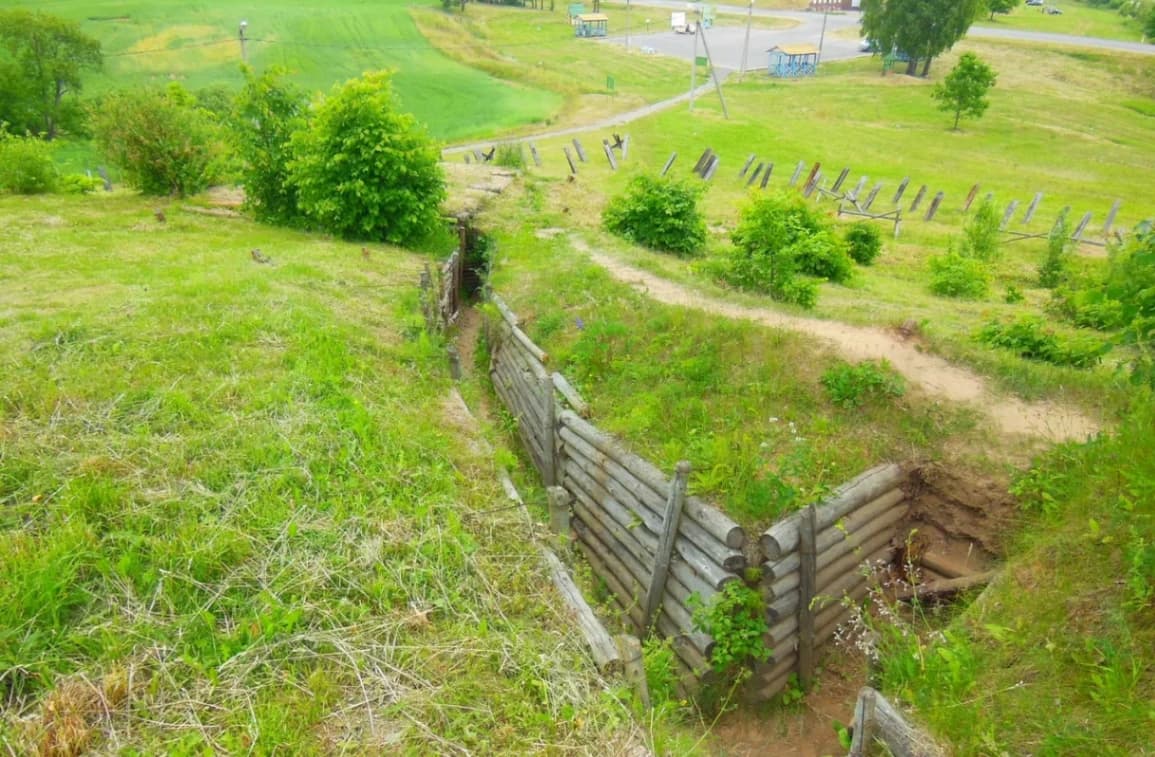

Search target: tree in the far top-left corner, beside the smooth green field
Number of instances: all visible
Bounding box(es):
[0,9,103,139]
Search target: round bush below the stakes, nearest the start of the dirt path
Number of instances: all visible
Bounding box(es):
[602,175,706,255]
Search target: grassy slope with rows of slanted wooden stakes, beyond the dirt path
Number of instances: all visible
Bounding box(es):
[471,42,1155,416]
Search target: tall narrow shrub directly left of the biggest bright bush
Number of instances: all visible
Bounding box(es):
[230,69,308,224]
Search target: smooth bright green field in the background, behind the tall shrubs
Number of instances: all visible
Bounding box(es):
[4,0,562,140]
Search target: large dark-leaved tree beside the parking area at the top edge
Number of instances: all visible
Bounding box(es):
[862,0,985,76]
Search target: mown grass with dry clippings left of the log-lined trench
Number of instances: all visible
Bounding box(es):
[0,195,631,754]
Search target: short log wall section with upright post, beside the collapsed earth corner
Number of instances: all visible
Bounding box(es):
[755,465,908,698]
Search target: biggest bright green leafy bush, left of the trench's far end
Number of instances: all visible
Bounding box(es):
[289,70,445,244]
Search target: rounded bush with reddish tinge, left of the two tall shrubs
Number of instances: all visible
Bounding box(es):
[92,83,224,196]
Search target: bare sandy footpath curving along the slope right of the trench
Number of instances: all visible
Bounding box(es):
[574,239,1100,441]
